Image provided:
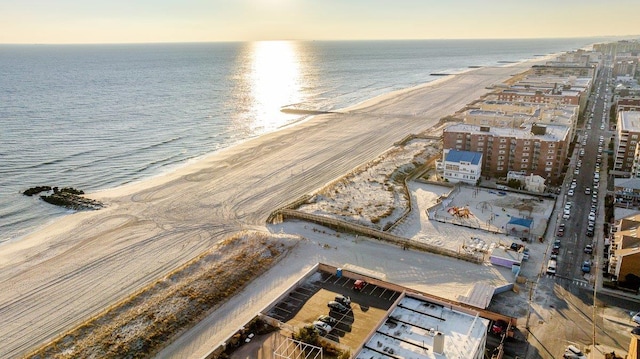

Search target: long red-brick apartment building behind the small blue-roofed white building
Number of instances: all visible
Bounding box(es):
[443,124,570,186]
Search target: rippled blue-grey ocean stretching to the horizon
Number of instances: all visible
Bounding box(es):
[0,38,603,244]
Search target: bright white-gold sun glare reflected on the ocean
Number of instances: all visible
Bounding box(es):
[248,41,302,129]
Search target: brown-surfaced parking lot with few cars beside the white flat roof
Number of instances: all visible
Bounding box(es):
[267,271,400,348]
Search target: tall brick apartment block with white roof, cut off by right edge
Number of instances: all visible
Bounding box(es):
[613,111,640,177]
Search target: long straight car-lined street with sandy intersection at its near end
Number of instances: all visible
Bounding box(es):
[526,57,640,358]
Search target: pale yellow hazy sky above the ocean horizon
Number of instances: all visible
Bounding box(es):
[0,0,640,44]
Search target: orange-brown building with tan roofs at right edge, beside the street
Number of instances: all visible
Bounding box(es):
[605,214,640,286]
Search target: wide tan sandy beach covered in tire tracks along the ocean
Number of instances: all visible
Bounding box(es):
[0,59,543,357]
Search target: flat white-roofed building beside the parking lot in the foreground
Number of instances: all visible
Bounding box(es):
[354,294,490,359]
